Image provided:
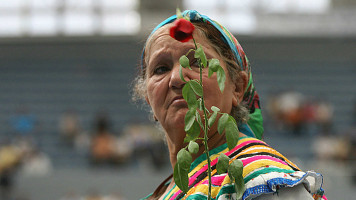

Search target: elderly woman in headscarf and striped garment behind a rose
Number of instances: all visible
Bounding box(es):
[135,10,326,200]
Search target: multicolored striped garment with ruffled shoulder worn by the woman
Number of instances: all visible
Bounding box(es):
[154,137,326,200]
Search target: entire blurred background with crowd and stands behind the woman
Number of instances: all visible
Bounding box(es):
[0,0,356,200]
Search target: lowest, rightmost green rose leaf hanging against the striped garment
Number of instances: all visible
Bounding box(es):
[228,160,246,199]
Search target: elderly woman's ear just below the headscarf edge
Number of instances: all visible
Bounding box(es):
[232,71,248,106]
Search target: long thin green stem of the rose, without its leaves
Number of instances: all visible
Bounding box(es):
[193,38,211,200]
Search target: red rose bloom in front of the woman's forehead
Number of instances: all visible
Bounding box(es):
[169,18,194,42]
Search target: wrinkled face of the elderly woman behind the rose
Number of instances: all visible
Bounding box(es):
[146,24,242,144]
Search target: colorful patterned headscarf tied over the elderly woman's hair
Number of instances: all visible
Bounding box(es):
[142,10,263,139]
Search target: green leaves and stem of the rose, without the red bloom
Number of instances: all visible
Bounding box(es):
[173,35,245,200]
